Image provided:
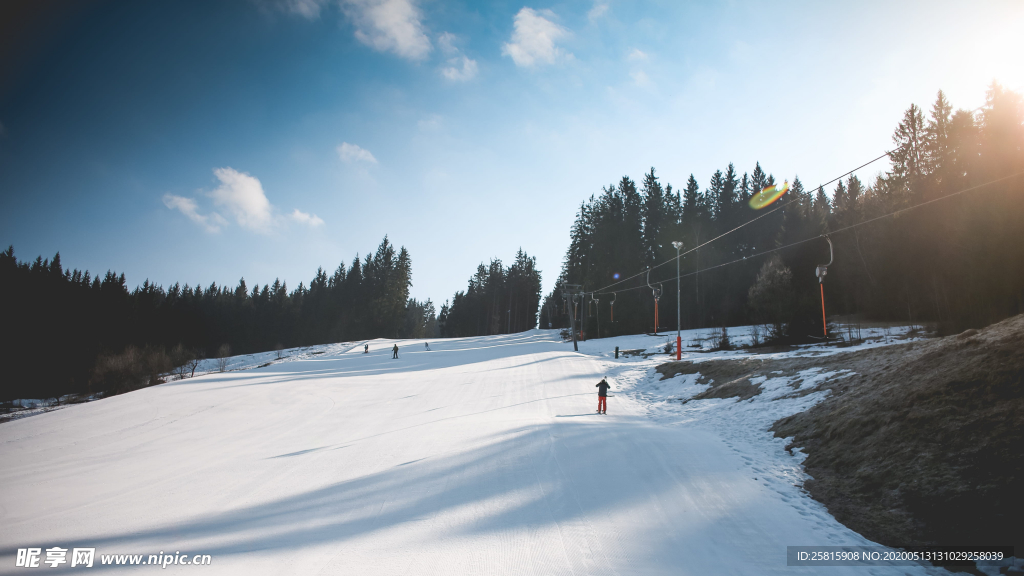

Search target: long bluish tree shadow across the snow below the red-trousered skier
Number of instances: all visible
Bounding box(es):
[9,414,750,574]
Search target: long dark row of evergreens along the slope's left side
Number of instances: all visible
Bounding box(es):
[0,237,438,400]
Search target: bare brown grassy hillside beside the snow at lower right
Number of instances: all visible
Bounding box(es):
[657,316,1024,550]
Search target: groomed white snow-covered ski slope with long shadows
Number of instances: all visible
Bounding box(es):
[0,330,932,575]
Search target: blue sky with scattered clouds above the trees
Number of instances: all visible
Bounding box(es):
[0,0,1024,304]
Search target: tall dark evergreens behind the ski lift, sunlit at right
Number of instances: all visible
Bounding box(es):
[541,83,1024,337]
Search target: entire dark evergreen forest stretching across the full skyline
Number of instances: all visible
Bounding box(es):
[0,83,1024,400]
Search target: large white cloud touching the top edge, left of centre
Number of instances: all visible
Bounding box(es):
[341,0,432,60]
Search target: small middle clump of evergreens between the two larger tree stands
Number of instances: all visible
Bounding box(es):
[438,248,541,336]
